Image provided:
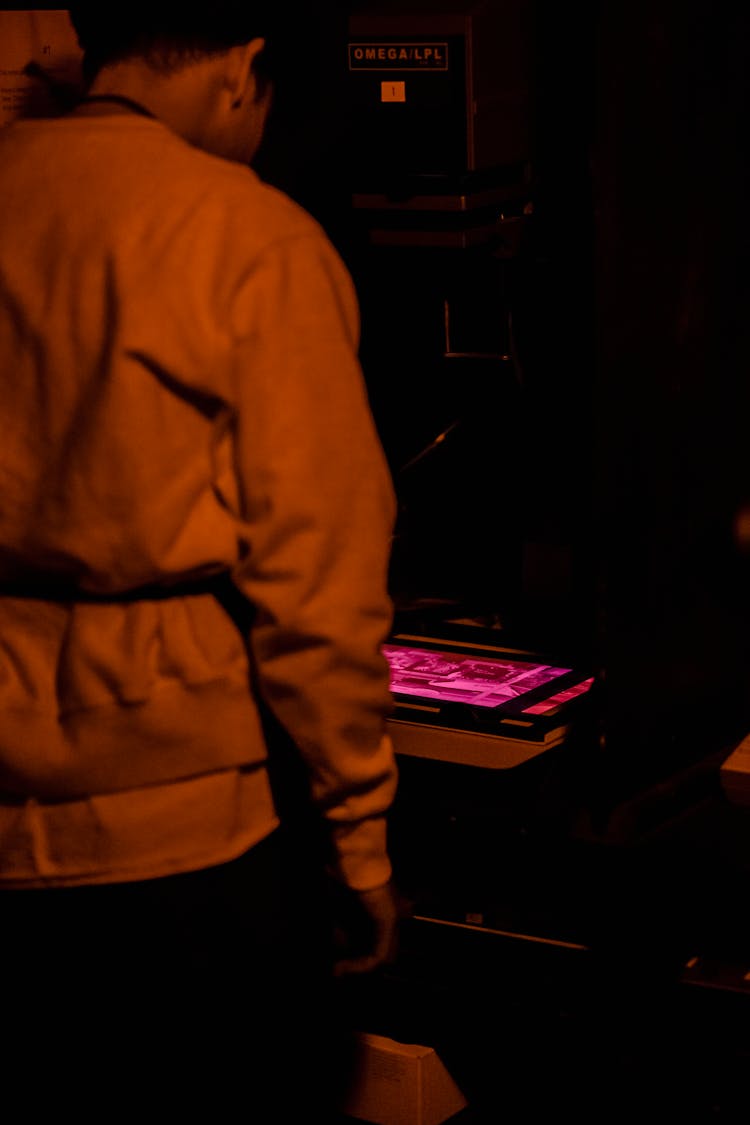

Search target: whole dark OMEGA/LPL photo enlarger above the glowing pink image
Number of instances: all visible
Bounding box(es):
[342,0,559,639]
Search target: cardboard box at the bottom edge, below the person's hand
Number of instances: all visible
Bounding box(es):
[344,1033,468,1125]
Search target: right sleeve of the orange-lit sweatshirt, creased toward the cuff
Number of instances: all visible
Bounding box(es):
[226,234,397,890]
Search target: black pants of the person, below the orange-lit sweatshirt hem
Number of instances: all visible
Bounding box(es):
[0,831,354,1125]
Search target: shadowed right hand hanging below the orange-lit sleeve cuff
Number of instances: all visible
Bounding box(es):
[334,883,403,977]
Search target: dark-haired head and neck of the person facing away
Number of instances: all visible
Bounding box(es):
[67,0,273,162]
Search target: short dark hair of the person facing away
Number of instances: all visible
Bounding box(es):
[67,0,274,81]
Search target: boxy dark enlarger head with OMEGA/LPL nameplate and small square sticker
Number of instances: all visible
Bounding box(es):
[346,0,531,246]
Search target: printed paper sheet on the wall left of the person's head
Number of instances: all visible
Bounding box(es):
[0,9,81,125]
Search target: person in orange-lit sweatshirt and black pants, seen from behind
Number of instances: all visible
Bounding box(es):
[0,2,398,1122]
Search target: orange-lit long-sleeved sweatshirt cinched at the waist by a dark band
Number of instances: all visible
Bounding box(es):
[0,115,396,889]
